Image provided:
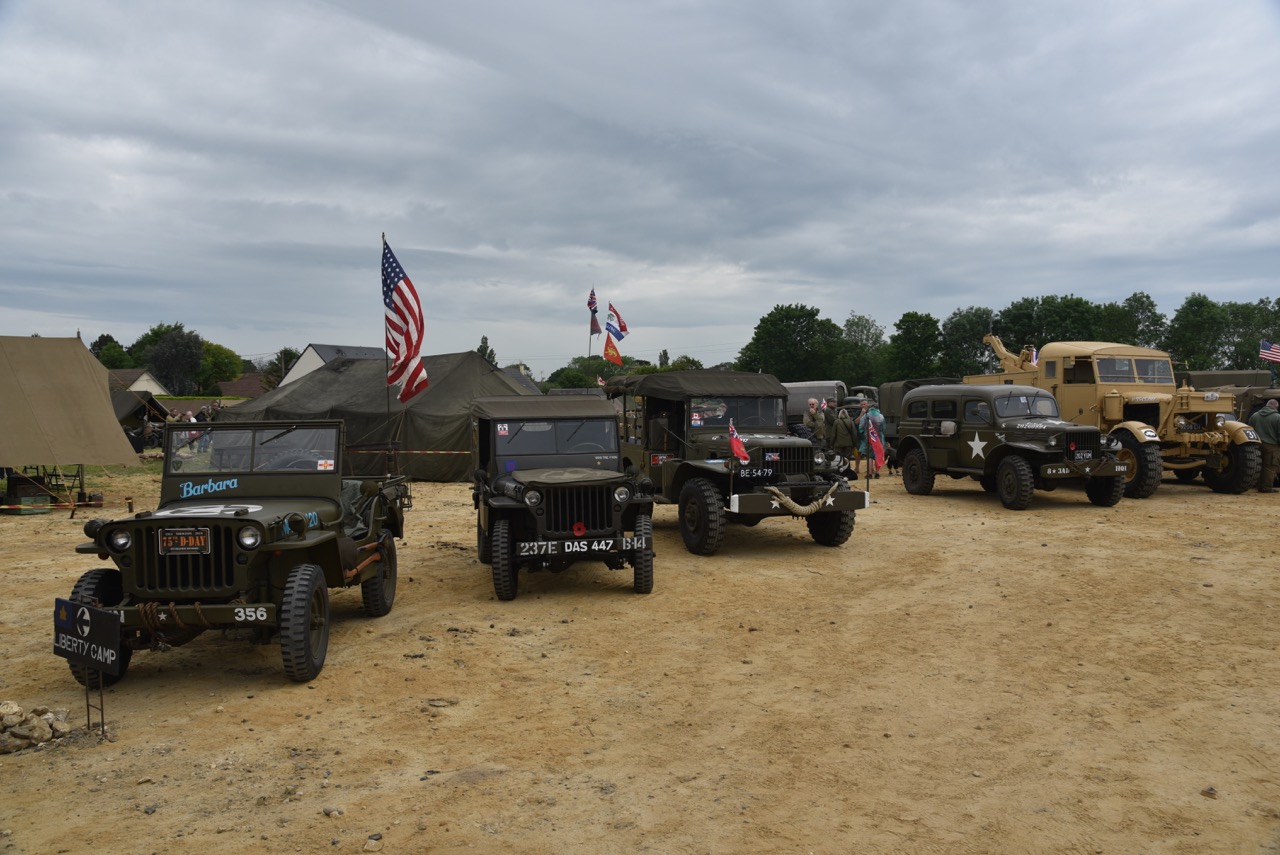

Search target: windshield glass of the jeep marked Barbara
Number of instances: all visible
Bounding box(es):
[165,422,338,476]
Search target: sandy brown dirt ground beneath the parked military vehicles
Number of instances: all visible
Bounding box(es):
[0,471,1280,855]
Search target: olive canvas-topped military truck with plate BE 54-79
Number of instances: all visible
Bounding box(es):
[604,370,869,555]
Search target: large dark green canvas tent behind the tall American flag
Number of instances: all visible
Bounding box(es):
[218,351,530,481]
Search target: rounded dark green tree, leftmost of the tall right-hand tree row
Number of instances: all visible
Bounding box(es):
[737,305,844,383]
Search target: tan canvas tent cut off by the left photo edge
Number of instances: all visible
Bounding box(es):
[0,335,138,468]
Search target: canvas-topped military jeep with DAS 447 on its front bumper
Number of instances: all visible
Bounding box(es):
[471,396,653,600]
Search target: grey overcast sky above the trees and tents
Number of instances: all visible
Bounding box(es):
[0,0,1280,376]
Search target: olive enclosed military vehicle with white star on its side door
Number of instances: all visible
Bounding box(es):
[897,384,1128,511]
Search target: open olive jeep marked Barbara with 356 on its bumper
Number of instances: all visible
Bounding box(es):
[70,421,411,685]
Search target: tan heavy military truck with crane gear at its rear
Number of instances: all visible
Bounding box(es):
[964,333,1262,499]
